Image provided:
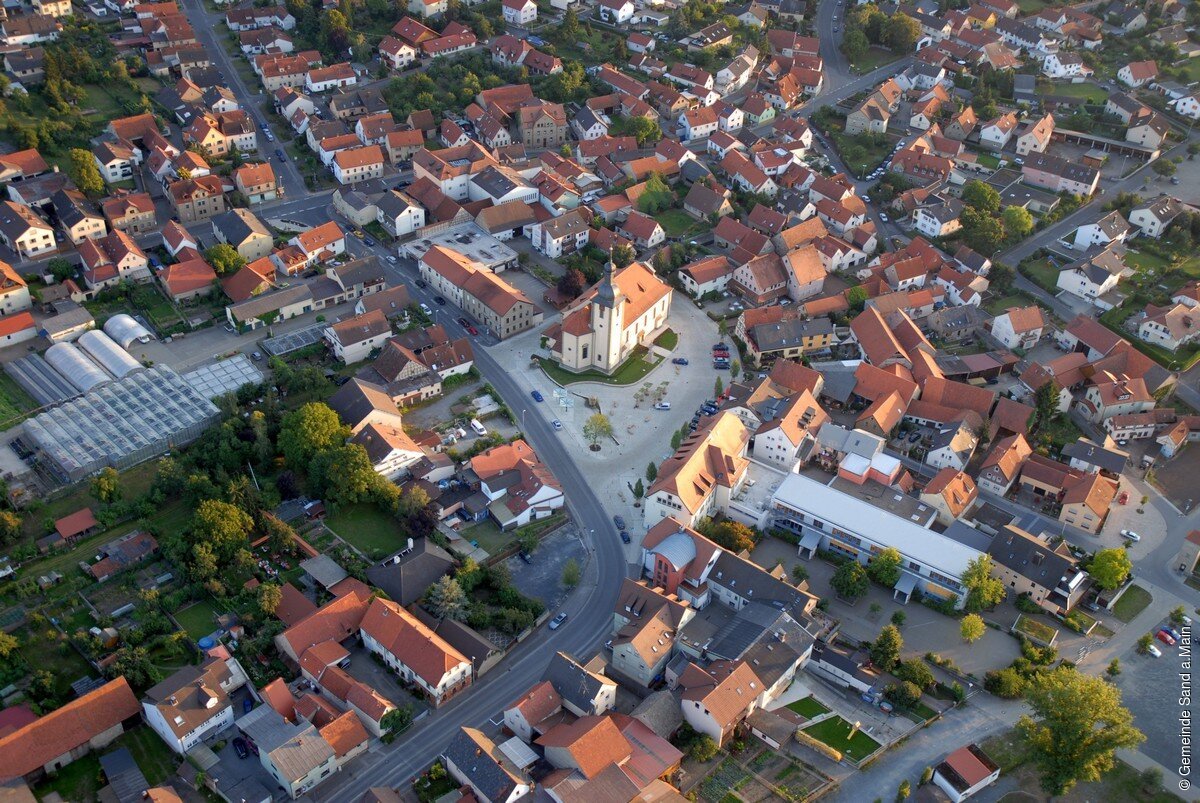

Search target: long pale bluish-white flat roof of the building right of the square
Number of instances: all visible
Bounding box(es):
[775,474,982,577]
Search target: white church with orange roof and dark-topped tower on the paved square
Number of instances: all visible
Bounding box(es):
[542,254,673,373]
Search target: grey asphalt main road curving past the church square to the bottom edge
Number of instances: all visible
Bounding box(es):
[304,238,629,801]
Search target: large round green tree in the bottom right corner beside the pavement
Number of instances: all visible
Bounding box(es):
[1016,667,1146,796]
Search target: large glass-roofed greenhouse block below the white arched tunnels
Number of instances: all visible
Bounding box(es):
[25,365,220,483]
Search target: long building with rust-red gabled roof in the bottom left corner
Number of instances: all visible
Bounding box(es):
[0,677,140,787]
